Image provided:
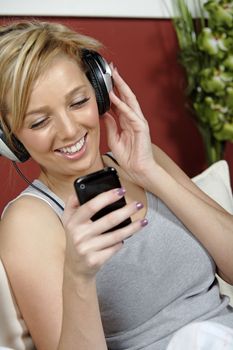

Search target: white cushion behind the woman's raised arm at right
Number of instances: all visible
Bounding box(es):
[192,160,233,306]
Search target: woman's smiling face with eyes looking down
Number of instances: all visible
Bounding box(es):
[16,57,102,177]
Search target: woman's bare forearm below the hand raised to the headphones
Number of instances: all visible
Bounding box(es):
[143,159,233,284]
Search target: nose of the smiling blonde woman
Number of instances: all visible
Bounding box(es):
[56,112,77,140]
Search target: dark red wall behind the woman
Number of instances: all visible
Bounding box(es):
[0,17,233,215]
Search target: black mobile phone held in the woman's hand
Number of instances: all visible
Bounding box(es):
[74,167,131,232]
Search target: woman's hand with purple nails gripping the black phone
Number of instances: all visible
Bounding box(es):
[62,189,145,279]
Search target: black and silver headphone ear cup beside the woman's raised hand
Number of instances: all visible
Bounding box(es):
[82,50,113,115]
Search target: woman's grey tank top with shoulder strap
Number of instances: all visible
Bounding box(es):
[5,180,233,350]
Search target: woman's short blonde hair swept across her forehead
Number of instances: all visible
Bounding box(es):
[0,21,101,146]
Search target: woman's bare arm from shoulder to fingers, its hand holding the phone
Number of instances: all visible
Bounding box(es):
[0,191,143,350]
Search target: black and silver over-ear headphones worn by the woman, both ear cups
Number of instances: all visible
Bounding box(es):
[0,49,113,163]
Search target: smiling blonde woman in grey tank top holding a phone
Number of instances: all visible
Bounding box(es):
[0,22,233,350]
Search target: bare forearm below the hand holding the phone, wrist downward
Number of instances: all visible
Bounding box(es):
[57,263,107,350]
